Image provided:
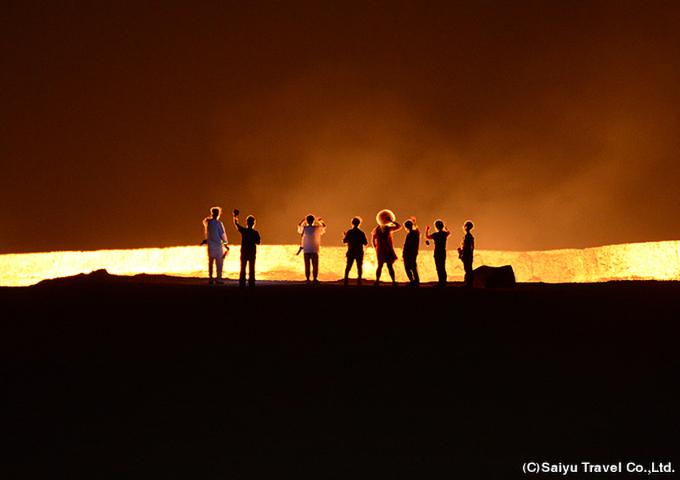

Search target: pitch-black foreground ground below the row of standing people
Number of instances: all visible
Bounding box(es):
[0,275,680,479]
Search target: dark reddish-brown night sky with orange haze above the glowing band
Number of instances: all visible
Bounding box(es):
[0,0,680,253]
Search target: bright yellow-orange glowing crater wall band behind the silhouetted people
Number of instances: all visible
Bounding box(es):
[0,241,680,286]
